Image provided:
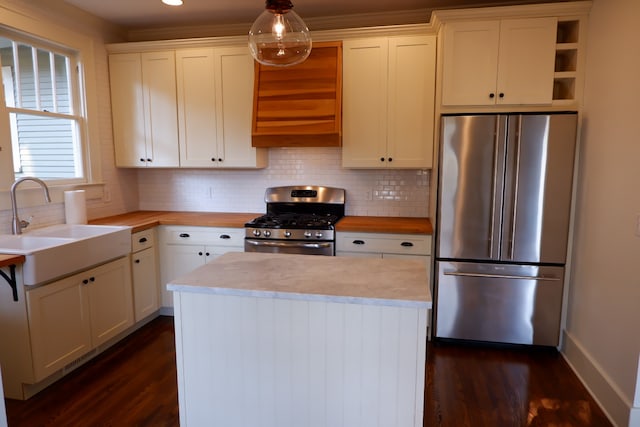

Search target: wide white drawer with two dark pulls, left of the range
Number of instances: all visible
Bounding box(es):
[162,226,244,247]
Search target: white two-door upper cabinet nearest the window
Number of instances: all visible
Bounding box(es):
[109,51,179,167]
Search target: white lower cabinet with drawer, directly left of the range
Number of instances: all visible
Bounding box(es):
[159,225,244,307]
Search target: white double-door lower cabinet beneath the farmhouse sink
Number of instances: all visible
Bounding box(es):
[26,257,133,382]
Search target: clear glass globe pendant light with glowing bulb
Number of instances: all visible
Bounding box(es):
[249,0,311,67]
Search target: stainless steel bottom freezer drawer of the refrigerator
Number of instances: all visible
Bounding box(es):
[435,262,564,346]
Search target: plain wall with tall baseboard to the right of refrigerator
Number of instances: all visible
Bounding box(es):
[564,0,640,426]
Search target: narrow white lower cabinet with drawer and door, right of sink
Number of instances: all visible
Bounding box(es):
[131,229,160,322]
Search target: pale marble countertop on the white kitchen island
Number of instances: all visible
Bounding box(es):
[167,252,432,309]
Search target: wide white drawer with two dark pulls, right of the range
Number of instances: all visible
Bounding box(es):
[336,233,431,255]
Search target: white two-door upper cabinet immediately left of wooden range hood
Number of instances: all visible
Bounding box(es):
[176,46,266,168]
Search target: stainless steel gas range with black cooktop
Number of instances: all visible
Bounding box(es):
[244,185,345,256]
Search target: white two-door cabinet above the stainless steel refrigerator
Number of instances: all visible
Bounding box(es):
[442,18,558,106]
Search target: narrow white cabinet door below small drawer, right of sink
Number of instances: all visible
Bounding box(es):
[131,248,158,322]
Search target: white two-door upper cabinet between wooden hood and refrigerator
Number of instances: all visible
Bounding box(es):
[342,36,436,168]
